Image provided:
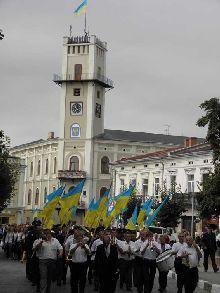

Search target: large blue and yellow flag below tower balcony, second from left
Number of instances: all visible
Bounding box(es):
[59,180,85,224]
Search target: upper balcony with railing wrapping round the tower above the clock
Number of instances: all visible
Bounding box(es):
[53,73,114,88]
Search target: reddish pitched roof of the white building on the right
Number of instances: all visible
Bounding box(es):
[113,142,211,165]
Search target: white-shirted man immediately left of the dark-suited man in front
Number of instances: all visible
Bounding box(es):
[69,234,91,293]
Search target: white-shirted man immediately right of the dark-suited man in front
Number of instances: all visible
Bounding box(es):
[117,231,135,291]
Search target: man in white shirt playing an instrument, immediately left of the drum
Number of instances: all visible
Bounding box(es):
[140,232,160,293]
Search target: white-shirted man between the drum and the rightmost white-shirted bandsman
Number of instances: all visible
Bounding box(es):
[172,233,186,293]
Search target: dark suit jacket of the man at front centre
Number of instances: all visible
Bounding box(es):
[95,244,118,278]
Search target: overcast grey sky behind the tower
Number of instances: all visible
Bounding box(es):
[0,0,220,145]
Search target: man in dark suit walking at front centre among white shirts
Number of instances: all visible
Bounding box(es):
[95,232,118,293]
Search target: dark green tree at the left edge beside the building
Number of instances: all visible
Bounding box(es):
[0,130,18,212]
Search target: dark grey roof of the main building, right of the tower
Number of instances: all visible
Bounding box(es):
[95,129,204,146]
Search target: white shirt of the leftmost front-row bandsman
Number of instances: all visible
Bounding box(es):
[33,238,63,259]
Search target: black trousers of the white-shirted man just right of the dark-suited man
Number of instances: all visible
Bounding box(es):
[118,258,133,289]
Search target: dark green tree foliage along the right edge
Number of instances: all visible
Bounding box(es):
[197,98,220,218]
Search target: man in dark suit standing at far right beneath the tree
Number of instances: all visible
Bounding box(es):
[201,227,219,273]
